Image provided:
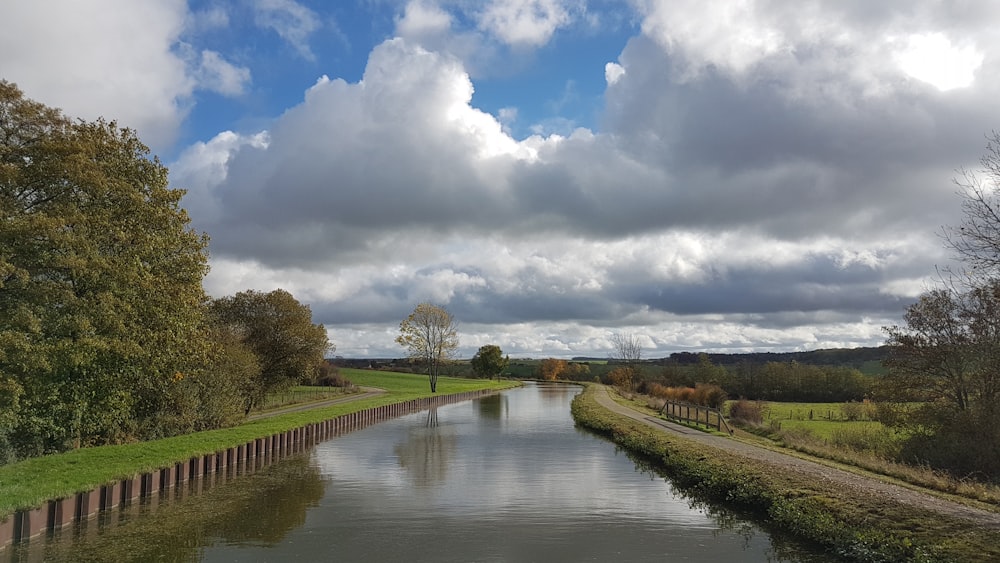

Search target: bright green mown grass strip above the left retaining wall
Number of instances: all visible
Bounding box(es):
[0,370,516,520]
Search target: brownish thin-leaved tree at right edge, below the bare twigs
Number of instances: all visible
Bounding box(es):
[878,281,1000,481]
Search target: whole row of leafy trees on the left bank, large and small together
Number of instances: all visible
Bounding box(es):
[0,81,330,463]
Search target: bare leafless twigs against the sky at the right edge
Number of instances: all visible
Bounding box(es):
[943,131,1000,280]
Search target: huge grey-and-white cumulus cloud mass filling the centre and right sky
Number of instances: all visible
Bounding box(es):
[179,2,1000,355]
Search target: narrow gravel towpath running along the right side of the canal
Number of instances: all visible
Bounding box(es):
[597,385,1000,529]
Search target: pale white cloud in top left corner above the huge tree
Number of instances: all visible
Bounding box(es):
[0,0,197,147]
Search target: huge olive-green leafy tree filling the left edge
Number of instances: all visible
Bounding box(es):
[0,81,207,457]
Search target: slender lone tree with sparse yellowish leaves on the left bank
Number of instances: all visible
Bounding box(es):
[396,303,458,393]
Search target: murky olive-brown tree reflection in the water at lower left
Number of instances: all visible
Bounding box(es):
[7,454,325,561]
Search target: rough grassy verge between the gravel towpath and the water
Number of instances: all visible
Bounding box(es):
[573,388,1000,562]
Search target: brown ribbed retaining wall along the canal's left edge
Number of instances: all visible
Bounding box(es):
[0,389,498,550]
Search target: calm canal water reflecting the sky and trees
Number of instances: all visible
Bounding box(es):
[9,384,832,563]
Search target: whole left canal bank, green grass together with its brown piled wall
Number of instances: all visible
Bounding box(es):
[0,375,514,550]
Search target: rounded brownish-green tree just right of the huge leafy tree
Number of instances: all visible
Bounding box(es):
[209,289,332,413]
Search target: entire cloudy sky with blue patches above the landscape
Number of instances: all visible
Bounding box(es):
[0,0,1000,358]
